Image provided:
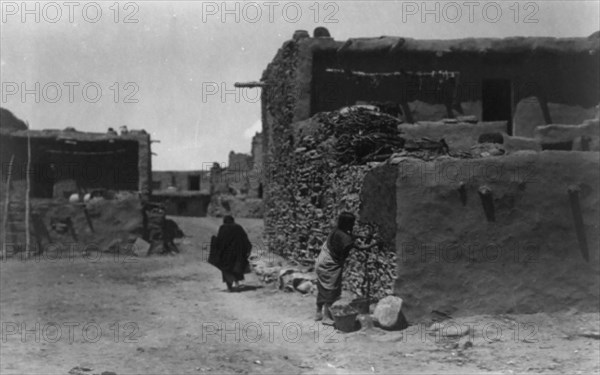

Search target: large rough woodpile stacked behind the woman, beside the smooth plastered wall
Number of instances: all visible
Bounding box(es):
[266,106,460,298]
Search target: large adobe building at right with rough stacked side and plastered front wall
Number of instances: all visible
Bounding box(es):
[252,28,600,320]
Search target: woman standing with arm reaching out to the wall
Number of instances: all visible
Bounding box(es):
[315,212,377,323]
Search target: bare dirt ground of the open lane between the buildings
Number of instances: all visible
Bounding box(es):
[0,218,600,374]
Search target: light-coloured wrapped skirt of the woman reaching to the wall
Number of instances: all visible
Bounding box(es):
[315,241,344,305]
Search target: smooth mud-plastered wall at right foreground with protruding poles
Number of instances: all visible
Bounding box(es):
[363,151,600,320]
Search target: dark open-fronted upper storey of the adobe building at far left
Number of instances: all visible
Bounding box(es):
[0,109,152,198]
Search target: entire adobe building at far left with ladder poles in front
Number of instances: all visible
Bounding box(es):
[0,109,155,256]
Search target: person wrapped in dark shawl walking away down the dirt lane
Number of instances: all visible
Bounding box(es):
[209,216,252,292]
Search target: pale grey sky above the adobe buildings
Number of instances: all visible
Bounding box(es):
[0,0,600,170]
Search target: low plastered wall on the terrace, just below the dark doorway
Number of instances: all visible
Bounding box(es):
[398,121,506,152]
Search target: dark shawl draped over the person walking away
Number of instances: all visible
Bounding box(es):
[208,223,252,275]
